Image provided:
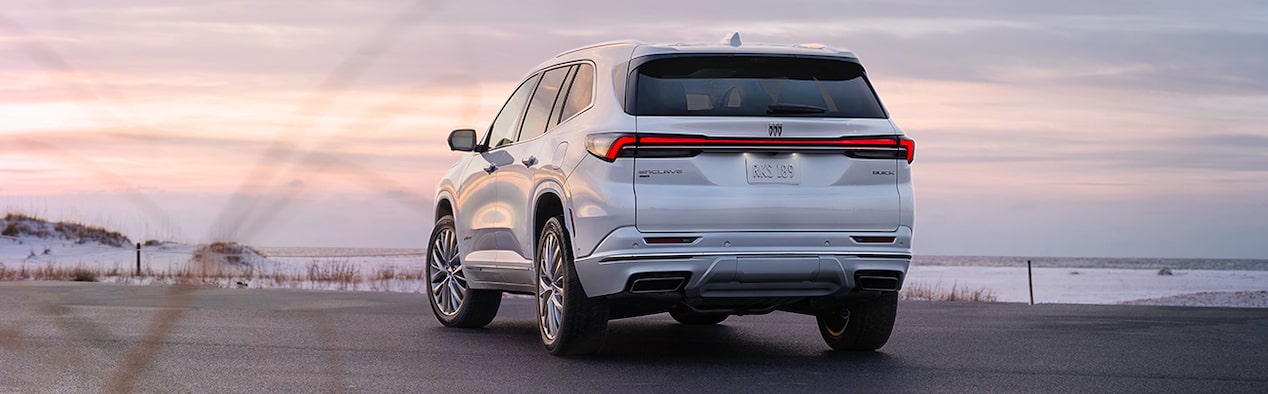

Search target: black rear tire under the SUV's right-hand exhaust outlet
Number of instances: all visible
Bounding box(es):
[818,291,898,351]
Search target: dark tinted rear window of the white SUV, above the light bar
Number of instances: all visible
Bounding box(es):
[626,56,886,118]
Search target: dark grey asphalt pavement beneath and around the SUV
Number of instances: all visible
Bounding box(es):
[0,283,1268,393]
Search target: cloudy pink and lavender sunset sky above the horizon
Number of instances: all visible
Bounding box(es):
[0,0,1268,258]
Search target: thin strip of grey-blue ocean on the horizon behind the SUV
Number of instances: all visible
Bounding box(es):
[256,247,1268,271]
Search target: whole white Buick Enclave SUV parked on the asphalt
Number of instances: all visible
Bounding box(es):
[427,34,915,355]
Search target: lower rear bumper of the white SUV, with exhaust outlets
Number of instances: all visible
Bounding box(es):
[576,227,912,299]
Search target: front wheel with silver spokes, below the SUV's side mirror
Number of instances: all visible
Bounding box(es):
[427,215,502,328]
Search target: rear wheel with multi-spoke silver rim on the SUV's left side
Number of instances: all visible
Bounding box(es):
[533,217,609,356]
